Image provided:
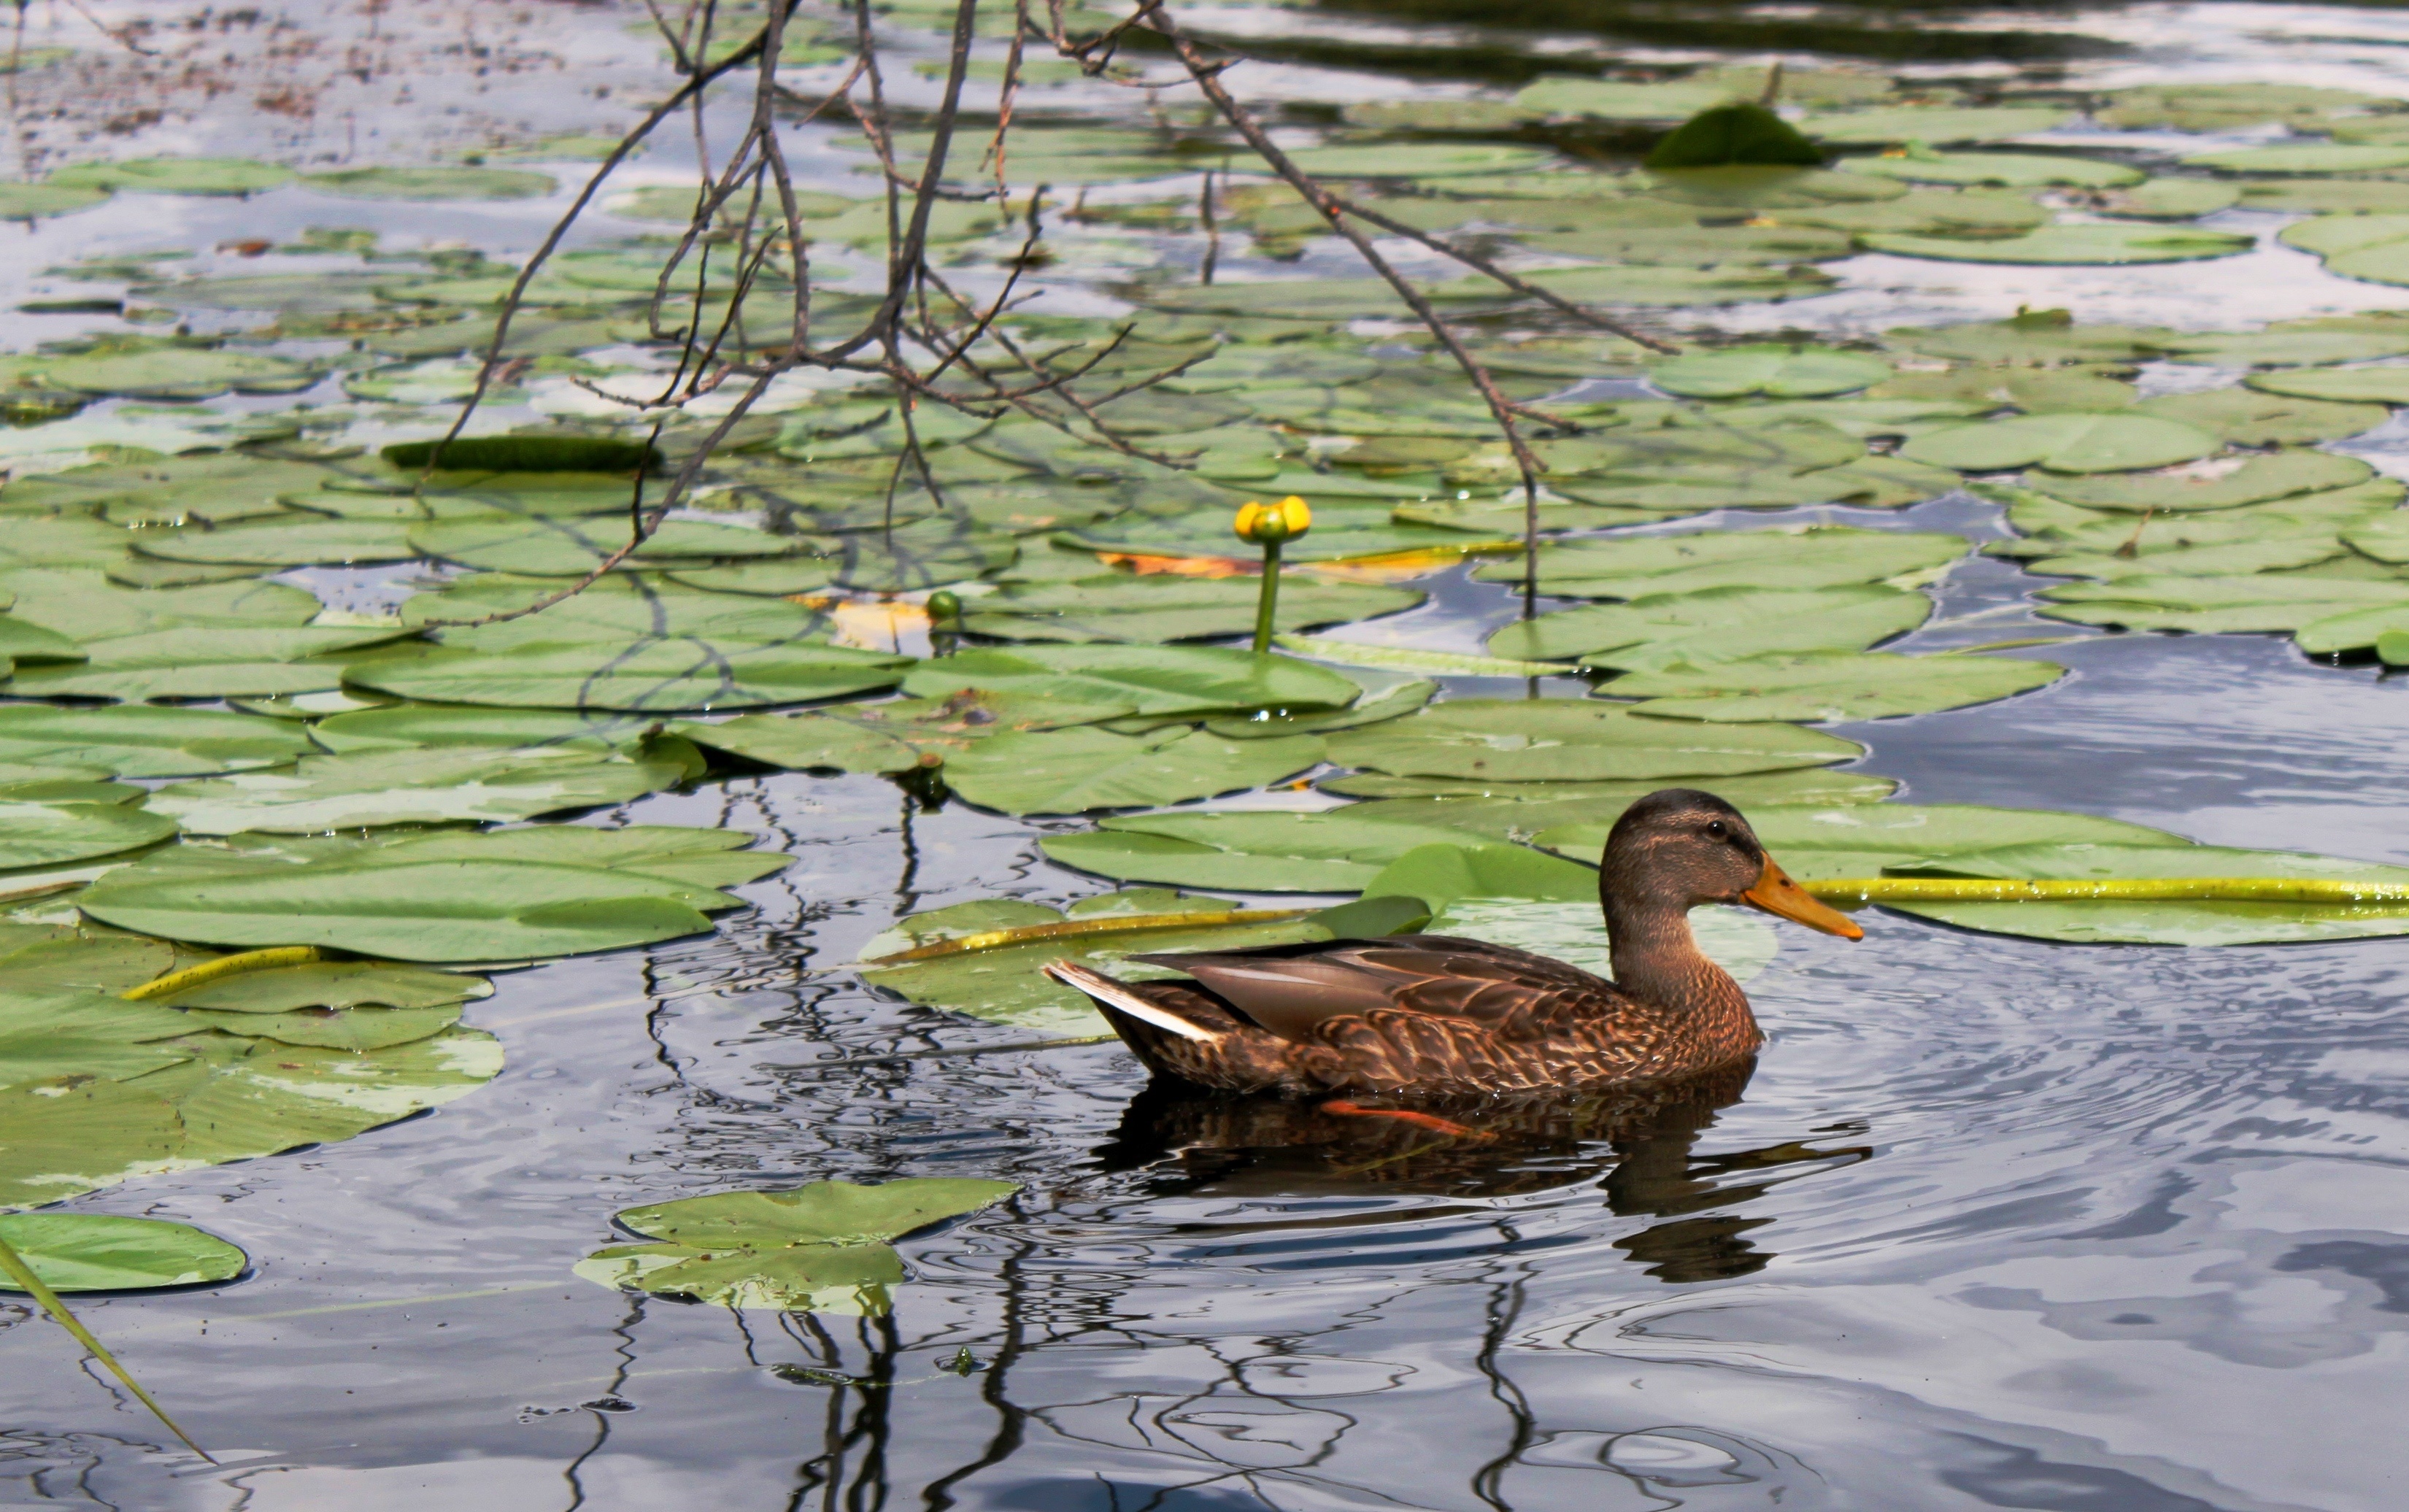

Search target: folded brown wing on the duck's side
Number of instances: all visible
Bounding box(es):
[1132,934,1622,1043]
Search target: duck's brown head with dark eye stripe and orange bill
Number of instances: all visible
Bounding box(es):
[1597,787,1865,939]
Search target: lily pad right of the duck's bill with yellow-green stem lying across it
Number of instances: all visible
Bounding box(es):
[1884,840,2409,946]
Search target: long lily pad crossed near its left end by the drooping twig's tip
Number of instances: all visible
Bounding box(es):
[1474,525,1968,600]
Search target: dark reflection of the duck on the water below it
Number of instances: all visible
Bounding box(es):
[1096,1060,1872,1284]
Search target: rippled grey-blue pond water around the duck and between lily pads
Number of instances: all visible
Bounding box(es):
[0,5,2409,1512]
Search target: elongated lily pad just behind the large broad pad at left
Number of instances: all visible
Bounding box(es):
[152,747,687,836]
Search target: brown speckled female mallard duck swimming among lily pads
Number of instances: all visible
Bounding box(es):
[1046,787,1865,1098]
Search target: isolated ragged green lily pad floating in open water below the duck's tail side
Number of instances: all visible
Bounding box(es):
[576,1177,1019,1314]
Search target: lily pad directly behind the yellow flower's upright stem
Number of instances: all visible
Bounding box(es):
[963,573,1426,643]
